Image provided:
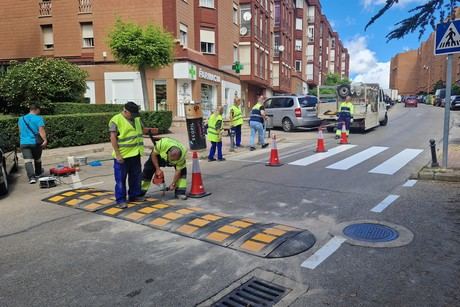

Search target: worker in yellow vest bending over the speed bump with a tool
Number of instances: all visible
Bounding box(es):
[142,138,187,200]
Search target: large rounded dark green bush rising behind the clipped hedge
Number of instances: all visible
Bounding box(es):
[0,57,88,114]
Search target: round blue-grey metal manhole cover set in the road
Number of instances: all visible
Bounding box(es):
[343,223,399,242]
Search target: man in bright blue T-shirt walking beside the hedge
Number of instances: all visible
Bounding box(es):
[18,104,48,184]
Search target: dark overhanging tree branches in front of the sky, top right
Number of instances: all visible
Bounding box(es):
[365,0,460,41]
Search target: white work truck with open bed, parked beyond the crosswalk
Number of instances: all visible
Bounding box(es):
[317,82,388,132]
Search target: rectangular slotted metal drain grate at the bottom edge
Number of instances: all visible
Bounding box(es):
[212,277,288,307]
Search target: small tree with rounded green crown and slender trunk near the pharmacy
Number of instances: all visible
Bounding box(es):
[109,19,174,110]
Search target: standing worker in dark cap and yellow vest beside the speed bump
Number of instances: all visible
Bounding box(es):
[109,101,144,209]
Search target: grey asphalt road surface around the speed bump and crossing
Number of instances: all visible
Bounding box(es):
[0,105,460,306]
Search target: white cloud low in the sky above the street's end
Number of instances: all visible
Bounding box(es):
[345,36,390,88]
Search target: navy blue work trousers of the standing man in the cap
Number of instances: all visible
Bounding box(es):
[113,155,142,204]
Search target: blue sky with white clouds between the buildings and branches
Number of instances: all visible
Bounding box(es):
[321,0,432,88]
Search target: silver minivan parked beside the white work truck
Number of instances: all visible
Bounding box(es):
[264,95,321,131]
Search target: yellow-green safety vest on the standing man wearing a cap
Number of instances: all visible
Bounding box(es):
[109,113,144,158]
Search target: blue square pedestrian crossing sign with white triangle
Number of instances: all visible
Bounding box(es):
[434,19,460,55]
